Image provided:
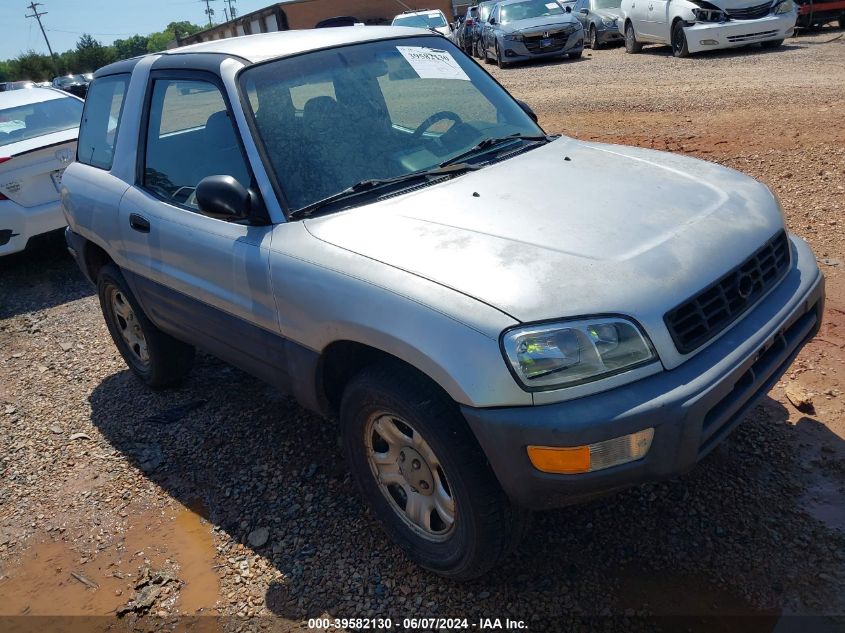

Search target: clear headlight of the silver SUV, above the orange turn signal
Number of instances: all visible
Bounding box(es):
[502,317,657,391]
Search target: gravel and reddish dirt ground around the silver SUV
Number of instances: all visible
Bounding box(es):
[0,29,845,631]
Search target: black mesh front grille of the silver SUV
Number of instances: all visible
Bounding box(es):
[663,231,789,354]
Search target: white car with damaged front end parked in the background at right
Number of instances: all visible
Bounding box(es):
[619,0,798,57]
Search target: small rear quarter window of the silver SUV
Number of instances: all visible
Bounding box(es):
[76,75,129,169]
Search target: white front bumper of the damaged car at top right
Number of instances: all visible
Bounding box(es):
[684,11,797,53]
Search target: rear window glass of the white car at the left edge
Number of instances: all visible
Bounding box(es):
[0,97,82,147]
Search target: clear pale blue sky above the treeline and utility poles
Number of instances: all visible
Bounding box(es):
[0,0,274,60]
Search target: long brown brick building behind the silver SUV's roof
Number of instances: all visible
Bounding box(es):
[174,0,463,46]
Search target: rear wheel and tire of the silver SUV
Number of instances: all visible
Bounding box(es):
[97,264,195,389]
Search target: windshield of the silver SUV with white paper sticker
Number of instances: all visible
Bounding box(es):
[240,36,543,210]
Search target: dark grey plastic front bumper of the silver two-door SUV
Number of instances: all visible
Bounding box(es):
[462,239,824,509]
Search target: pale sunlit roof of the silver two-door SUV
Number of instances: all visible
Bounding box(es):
[161,26,432,63]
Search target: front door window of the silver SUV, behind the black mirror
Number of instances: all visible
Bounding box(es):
[143,79,250,209]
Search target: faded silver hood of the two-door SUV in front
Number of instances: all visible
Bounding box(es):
[306,138,783,366]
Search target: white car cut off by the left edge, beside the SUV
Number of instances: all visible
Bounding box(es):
[0,88,83,256]
